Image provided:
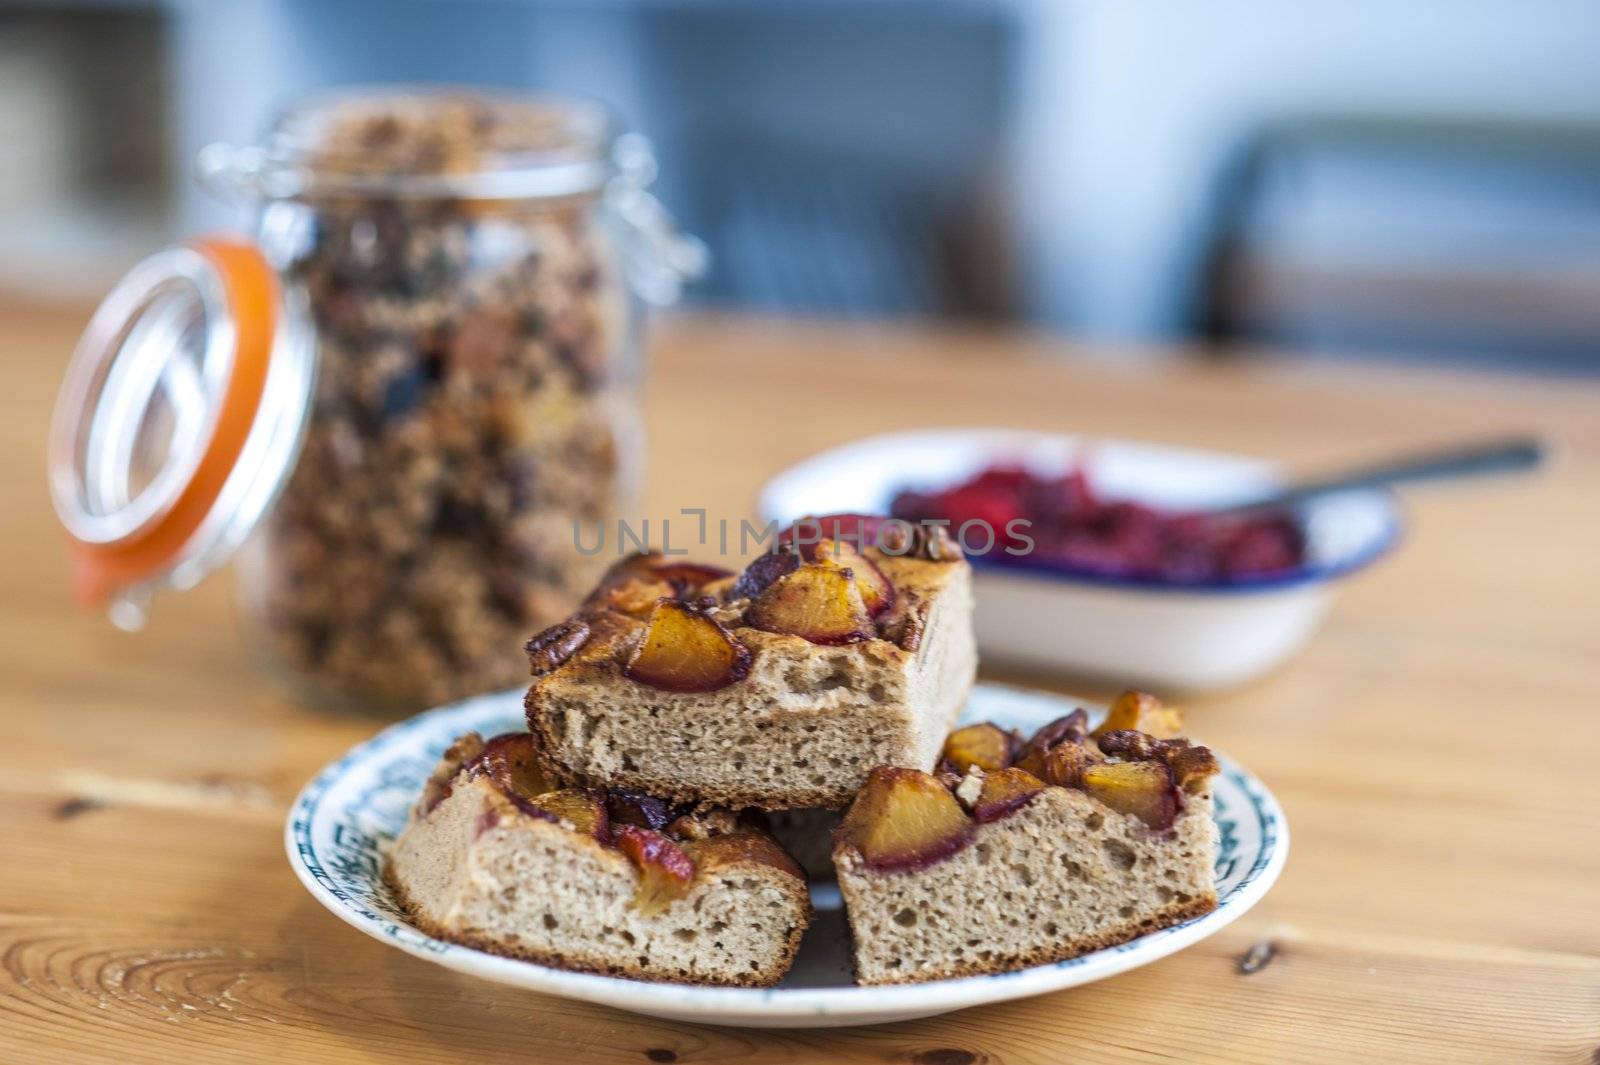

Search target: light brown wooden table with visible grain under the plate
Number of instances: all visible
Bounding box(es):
[0,299,1600,1065]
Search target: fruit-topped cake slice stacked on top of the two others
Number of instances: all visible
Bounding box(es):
[526,514,978,809]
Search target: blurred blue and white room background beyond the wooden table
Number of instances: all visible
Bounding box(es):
[0,0,1600,374]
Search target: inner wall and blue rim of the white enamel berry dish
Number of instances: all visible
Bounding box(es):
[758,429,1403,595]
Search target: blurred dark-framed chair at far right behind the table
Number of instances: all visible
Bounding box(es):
[1192,117,1600,373]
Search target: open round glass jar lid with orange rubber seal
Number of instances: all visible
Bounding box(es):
[48,237,315,628]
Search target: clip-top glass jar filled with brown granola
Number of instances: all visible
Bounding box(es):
[50,90,704,712]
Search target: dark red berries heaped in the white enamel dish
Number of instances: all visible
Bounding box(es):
[890,465,1306,584]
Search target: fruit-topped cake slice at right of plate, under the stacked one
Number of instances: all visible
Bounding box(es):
[834,692,1218,983]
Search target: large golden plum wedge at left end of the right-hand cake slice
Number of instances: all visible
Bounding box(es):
[838,766,973,872]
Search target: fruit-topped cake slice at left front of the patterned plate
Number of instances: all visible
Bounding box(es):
[387,732,811,987]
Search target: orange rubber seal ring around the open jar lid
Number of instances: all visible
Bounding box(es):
[70,237,280,606]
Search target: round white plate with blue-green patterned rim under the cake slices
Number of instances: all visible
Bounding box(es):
[283,684,1290,1028]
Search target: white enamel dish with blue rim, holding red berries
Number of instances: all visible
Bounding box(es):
[758,429,1400,691]
